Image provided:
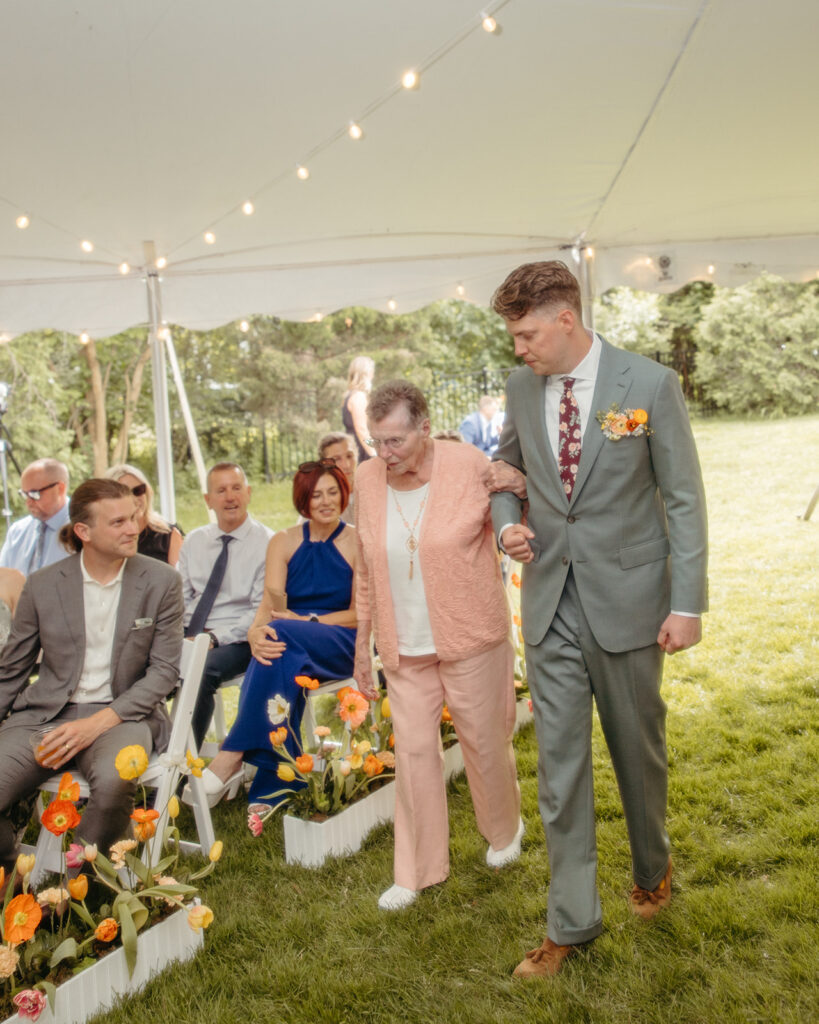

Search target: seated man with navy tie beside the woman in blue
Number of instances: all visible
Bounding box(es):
[177,462,273,746]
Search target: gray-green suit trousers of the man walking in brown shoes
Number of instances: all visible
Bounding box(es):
[526,571,669,945]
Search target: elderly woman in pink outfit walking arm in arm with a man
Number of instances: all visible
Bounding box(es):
[354,381,523,910]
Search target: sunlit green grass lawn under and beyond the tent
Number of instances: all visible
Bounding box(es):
[99,417,819,1024]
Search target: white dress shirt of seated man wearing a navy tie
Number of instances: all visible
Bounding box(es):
[177,516,273,646]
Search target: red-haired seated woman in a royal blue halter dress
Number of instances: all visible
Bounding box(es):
[203,459,356,803]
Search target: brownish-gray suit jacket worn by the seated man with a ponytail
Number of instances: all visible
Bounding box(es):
[0,555,183,750]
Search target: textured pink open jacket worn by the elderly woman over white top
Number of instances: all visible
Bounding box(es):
[355,441,509,669]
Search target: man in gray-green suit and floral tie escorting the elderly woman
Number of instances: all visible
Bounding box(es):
[489,261,707,977]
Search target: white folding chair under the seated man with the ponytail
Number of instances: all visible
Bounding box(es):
[27,633,210,886]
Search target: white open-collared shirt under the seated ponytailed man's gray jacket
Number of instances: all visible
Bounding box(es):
[70,552,126,703]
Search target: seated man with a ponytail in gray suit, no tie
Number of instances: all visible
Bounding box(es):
[0,479,183,871]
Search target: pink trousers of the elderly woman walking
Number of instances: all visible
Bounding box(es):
[387,640,520,890]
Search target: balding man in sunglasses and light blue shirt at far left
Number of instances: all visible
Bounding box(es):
[0,459,69,577]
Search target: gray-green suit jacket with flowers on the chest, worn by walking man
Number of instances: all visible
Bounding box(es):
[491,341,707,651]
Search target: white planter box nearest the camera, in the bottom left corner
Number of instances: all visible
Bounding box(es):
[3,910,205,1024]
